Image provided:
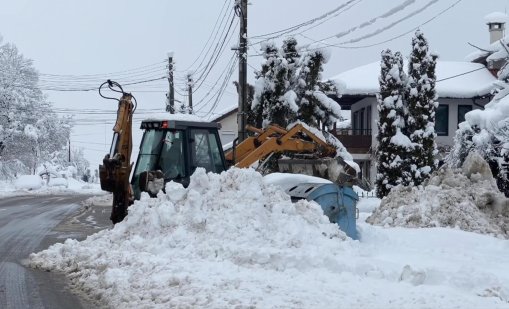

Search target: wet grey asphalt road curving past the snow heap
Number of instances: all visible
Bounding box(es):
[0,195,111,309]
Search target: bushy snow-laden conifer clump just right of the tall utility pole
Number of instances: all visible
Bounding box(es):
[251,38,341,128]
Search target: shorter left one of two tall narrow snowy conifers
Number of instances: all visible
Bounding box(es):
[376,50,412,198]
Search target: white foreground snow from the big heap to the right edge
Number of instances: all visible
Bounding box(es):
[29,169,509,308]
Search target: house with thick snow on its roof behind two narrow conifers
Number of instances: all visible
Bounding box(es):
[331,61,495,182]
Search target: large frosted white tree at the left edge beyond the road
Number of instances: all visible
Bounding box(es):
[0,37,79,178]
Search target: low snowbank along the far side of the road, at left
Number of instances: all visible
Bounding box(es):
[0,175,105,197]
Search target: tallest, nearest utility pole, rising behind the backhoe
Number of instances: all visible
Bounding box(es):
[235,0,247,142]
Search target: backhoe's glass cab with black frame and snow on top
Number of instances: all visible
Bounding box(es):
[131,115,226,199]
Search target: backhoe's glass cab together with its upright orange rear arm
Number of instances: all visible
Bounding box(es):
[99,80,226,224]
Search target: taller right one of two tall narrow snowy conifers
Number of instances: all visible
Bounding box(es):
[405,30,438,185]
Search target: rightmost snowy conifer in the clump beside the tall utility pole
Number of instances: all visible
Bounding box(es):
[295,48,341,128]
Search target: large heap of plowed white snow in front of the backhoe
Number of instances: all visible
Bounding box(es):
[30,169,350,308]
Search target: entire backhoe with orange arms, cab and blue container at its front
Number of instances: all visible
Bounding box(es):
[99,81,358,237]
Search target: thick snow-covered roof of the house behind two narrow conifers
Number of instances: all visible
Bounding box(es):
[331,61,496,98]
